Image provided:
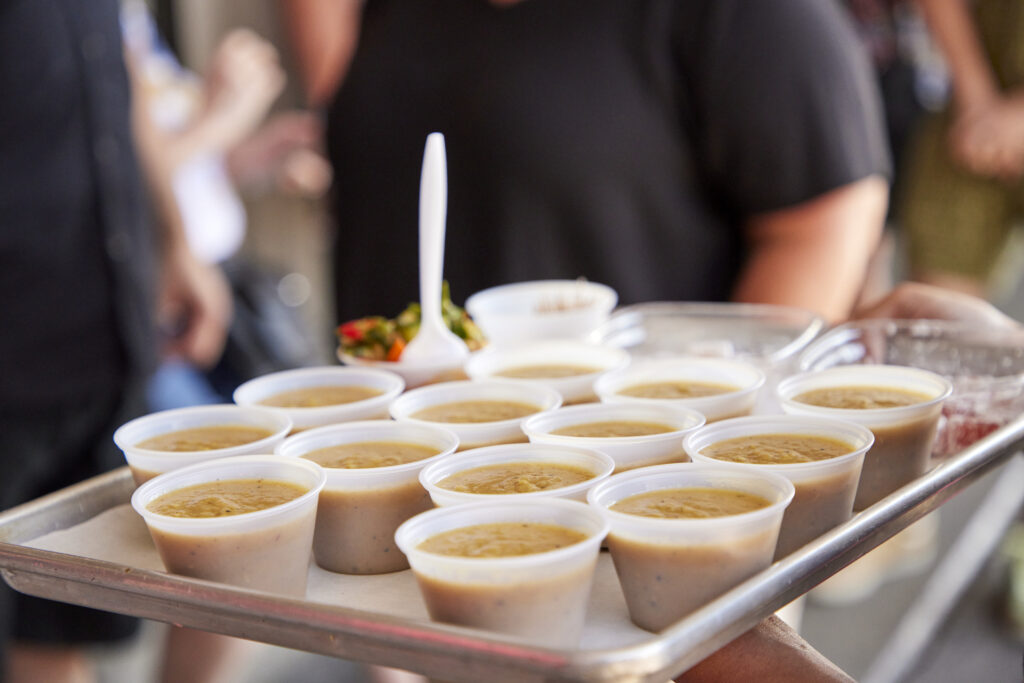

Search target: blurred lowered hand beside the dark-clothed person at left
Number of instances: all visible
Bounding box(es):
[157,246,231,368]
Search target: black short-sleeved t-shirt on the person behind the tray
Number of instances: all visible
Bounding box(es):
[328,0,888,319]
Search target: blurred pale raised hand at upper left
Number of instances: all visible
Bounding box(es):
[201,29,287,151]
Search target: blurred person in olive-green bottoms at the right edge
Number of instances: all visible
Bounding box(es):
[899,0,1024,297]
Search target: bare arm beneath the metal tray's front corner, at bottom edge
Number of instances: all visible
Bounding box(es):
[676,616,853,683]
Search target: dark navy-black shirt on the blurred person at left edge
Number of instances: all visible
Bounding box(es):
[0,0,155,411]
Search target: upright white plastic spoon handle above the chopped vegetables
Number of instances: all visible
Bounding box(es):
[420,133,447,331]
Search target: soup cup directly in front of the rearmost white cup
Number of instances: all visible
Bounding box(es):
[466,341,630,404]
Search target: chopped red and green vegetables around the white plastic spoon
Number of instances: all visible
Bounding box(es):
[338,283,486,360]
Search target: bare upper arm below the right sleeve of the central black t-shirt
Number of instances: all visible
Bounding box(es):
[733,176,889,322]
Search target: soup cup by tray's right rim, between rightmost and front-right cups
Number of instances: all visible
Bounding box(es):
[683,415,874,559]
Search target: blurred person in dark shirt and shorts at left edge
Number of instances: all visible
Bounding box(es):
[0,0,230,683]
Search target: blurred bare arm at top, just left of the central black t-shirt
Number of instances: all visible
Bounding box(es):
[280,0,362,108]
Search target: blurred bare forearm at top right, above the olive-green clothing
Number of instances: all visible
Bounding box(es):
[918,0,998,114]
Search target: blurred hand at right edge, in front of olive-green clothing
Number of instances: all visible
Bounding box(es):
[949,96,1024,182]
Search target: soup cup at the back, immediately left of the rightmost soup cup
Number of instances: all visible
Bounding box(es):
[594,357,765,422]
